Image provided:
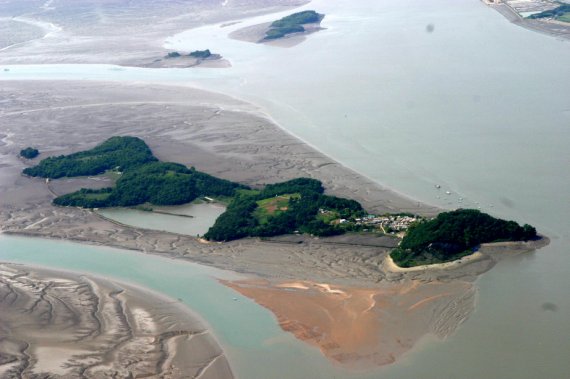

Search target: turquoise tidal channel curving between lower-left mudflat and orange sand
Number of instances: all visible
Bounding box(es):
[0,234,404,379]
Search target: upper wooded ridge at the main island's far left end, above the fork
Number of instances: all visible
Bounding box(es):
[24,137,157,179]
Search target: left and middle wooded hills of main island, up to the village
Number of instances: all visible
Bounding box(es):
[23,136,366,241]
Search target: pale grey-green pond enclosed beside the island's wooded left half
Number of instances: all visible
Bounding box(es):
[97,203,225,236]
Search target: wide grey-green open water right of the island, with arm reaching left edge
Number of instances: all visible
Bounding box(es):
[0,0,570,379]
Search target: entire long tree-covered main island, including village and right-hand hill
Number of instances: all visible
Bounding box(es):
[23,137,537,267]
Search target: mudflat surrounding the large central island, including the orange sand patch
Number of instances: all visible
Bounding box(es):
[0,81,544,372]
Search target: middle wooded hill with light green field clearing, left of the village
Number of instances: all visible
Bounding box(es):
[204,178,366,241]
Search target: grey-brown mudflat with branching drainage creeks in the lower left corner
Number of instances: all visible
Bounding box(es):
[0,264,233,379]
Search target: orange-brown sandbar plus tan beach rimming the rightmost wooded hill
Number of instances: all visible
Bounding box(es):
[222,238,548,369]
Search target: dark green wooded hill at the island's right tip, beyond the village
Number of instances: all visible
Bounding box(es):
[391,209,537,267]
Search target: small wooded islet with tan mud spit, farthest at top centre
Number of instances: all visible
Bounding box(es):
[230,10,325,46]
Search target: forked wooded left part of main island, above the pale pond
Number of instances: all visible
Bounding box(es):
[24,137,245,208]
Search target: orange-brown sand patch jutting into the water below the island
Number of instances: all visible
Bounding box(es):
[223,280,473,368]
